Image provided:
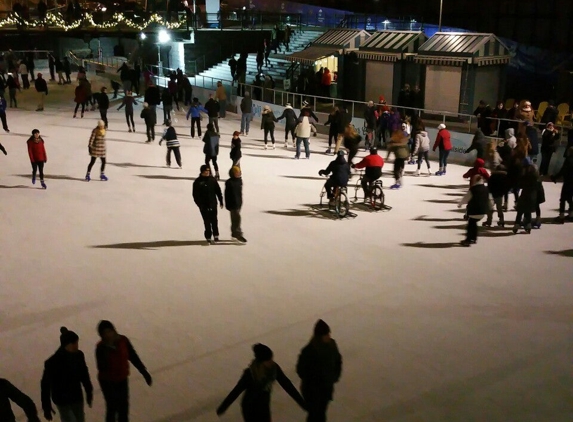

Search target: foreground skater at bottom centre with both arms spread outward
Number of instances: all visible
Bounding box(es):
[217,343,306,422]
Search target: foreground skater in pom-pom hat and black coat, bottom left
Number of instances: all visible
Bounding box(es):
[41,327,93,422]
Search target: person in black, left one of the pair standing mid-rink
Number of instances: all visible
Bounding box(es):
[193,164,223,244]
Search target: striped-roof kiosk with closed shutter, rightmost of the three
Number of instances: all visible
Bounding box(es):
[414,32,511,114]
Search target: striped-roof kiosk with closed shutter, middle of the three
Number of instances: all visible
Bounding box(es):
[356,31,428,104]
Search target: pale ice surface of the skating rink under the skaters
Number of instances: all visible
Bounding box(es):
[0,80,573,422]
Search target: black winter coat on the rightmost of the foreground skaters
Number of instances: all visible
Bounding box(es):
[296,339,342,404]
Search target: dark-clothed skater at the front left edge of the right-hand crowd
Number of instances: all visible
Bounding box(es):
[458,174,491,246]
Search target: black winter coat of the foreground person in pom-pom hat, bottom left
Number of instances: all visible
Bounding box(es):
[41,348,93,410]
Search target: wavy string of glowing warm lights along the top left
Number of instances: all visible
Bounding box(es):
[0,13,185,31]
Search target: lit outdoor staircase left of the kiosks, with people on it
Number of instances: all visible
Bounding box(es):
[190,30,324,89]
